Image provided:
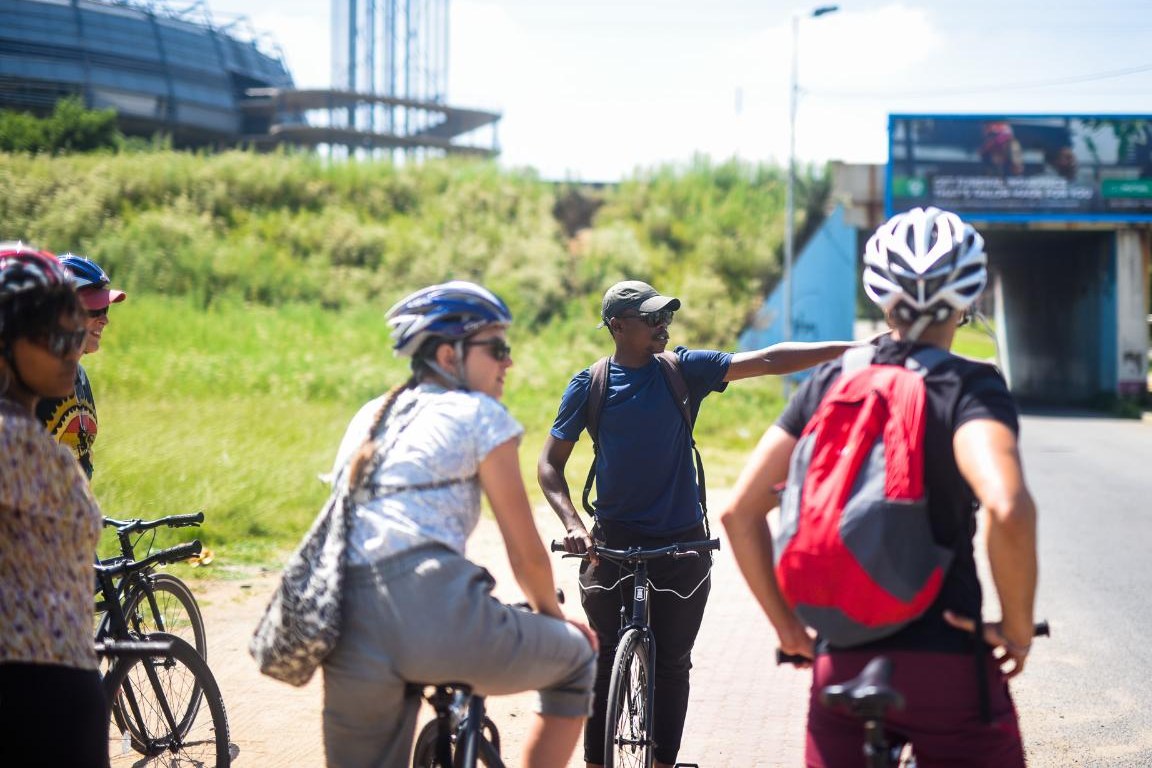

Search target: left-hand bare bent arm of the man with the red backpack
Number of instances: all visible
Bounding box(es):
[720,425,816,659]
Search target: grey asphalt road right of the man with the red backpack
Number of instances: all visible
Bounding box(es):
[1014,412,1152,768]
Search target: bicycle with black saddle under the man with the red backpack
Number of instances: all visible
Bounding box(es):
[776,622,1051,768]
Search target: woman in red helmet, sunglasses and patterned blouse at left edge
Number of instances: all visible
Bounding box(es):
[0,243,108,768]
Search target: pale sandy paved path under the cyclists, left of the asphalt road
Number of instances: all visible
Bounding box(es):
[186,504,805,768]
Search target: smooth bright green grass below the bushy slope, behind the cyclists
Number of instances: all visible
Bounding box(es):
[84,294,782,564]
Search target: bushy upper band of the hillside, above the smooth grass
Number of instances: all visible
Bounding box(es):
[0,152,801,343]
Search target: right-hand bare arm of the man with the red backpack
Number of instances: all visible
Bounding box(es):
[953,419,1039,676]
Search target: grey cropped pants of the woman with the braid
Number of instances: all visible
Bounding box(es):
[324,546,596,768]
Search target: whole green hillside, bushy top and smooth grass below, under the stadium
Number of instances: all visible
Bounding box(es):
[0,151,820,563]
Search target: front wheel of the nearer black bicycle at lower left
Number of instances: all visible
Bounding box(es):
[104,632,232,768]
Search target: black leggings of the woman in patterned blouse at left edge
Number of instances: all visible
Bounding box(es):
[0,662,108,768]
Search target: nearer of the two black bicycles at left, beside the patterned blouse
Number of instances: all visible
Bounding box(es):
[96,542,233,768]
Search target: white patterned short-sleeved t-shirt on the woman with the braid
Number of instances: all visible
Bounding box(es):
[333,383,524,564]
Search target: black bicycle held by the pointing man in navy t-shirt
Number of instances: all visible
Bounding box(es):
[552,539,720,768]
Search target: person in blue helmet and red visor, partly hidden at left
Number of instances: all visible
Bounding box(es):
[36,253,128,479]
